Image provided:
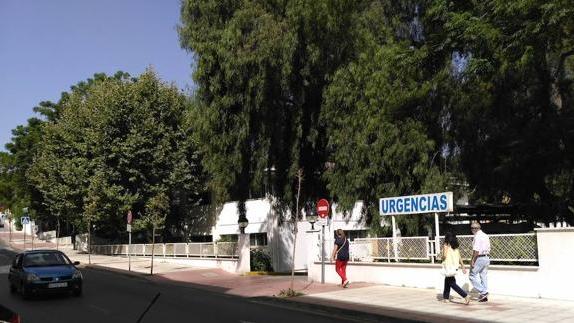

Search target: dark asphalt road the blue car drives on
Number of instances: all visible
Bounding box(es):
[0,241,362,323]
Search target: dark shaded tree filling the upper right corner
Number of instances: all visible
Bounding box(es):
[425,0,574,221]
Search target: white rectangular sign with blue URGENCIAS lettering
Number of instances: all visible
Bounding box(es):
[379,192,454,215]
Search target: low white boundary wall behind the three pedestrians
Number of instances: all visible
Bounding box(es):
[308,228,574,300]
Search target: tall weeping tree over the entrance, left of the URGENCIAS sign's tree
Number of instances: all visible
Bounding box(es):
[179,0,364,220]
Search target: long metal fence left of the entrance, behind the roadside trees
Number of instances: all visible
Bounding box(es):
[91,242,238,258]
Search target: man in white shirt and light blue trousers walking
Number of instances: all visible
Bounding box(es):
[469,222,490,302]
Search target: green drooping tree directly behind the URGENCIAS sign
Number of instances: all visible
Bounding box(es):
[323,2,452,234]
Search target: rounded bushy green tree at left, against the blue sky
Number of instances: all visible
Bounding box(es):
[32,71,209,239]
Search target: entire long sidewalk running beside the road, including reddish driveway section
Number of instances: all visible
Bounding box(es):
[0,234,574,322]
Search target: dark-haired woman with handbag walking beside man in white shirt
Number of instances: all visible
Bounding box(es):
[442,232,470,305]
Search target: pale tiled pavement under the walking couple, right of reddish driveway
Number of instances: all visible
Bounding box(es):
[295,285,574,322]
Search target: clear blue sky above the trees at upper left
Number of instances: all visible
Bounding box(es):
[0,0,193,151]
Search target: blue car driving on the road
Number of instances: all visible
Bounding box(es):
[8,250,83,299]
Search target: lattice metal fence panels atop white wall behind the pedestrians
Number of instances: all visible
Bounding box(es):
[316,233,538,264]
